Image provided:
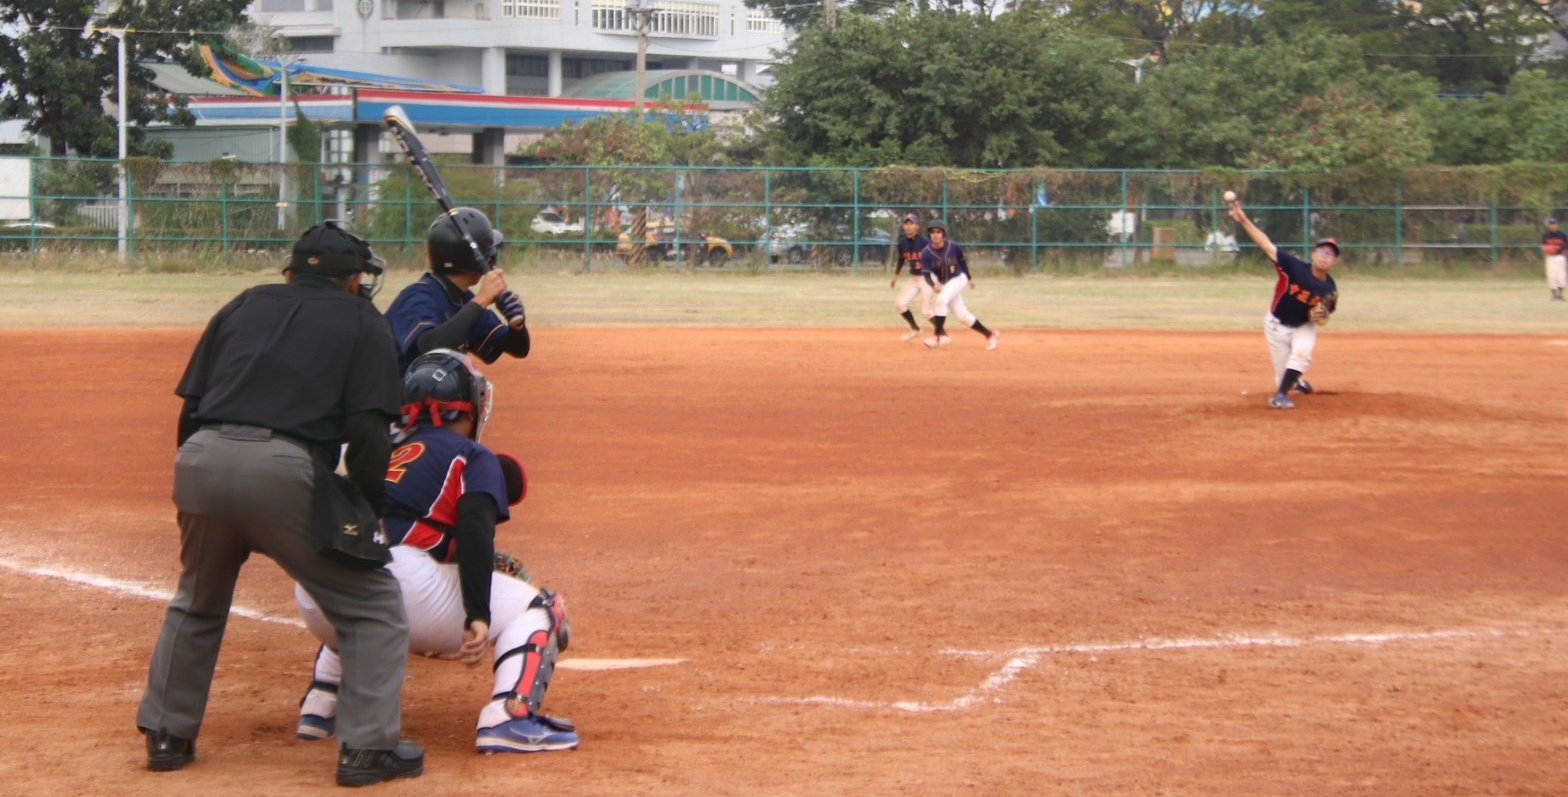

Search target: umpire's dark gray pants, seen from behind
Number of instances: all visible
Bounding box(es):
[136,424,408,750]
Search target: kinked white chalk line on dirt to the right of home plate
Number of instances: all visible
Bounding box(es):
[756,629,1557,712]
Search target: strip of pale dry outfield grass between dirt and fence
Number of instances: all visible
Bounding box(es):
[0,268,1568,334]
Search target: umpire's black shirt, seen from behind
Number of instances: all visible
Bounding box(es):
[174,271,401,511]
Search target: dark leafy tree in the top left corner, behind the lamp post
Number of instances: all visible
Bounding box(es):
[0,0,249,157]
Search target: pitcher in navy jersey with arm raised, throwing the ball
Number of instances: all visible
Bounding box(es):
[1231,201,1339,409]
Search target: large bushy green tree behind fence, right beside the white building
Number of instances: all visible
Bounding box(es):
[759,8,1132,168]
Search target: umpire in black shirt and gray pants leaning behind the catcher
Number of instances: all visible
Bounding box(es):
[136,221,425,786]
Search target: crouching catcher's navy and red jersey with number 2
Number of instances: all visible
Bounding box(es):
[386,427,511,562]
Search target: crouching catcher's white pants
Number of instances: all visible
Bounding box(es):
[295,546,550,721]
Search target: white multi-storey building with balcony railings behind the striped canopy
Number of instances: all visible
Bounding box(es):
[257,0,786,97]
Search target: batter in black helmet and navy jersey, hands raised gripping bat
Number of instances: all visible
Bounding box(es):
[386,207,532,369]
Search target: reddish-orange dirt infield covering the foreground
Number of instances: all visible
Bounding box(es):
[0,328,1568,797]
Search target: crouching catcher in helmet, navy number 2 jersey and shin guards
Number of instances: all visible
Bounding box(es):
[295,350,577,753]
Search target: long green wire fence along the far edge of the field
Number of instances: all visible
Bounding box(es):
[0,157,1568,271]
